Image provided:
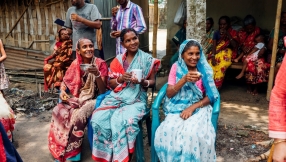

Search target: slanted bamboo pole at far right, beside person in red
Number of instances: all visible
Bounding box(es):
[266,0,282,101]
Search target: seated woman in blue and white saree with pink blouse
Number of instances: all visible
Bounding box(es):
[154,39,218,162]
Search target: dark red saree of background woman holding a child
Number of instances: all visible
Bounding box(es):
[238,27,269,84]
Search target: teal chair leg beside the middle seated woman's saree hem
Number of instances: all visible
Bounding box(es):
[135,121,145,162]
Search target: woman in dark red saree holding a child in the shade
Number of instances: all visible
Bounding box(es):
[235,15,268,95]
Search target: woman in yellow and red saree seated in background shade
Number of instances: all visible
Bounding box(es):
[208,16,237,89]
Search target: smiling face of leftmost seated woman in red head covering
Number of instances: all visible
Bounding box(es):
[77,39,94,59]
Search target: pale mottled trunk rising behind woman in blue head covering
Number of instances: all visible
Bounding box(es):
[186,0,206,42]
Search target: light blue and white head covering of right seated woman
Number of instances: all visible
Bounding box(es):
[177,39,219,103]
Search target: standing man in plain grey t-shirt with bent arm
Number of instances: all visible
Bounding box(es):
[65,0,103,59]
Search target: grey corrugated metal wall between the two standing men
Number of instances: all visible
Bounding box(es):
[94,0,117,59]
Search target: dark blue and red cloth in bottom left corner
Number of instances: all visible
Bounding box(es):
[0,123,23,162]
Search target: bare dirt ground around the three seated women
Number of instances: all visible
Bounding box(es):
[6,67,269,162]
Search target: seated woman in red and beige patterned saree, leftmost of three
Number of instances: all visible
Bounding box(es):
[48,39,108,162]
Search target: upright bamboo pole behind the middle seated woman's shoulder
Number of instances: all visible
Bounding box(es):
[152,0,158,58]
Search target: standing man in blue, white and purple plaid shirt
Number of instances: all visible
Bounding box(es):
[110,0,147,55]
